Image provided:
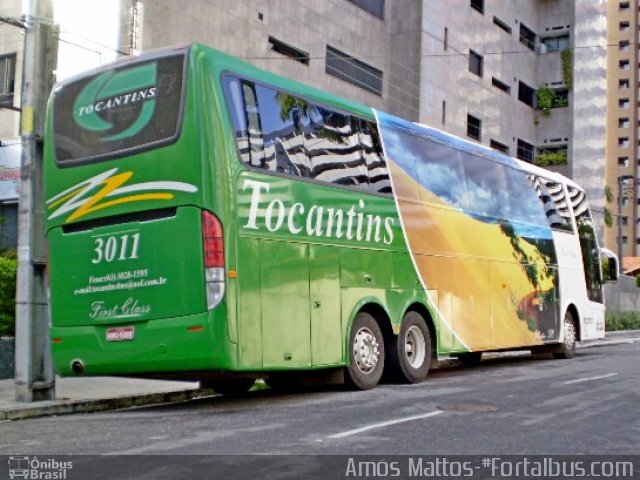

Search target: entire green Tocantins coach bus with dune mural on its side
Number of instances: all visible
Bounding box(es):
[45,44,616,393]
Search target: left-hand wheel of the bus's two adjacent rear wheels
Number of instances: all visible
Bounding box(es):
[345,312,384,390]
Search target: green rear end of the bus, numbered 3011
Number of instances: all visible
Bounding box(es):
[45,47,229,375]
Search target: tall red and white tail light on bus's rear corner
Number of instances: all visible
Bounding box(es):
[202,210,225,310]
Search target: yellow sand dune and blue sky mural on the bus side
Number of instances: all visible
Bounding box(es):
[376,112,558,350]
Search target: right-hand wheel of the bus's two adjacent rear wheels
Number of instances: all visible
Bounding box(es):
[387,312,431,383]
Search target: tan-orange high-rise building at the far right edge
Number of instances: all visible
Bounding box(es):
[606,0,640,257]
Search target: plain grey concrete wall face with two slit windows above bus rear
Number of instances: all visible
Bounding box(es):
[143,0,396,109]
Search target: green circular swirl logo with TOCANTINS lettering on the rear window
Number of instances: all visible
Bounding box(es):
[73,62,158,141]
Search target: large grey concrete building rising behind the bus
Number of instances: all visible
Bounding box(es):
[0,0,607,246]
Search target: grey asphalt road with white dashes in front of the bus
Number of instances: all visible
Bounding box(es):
[0,341,640,455]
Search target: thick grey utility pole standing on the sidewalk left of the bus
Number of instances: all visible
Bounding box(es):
[15,0,58,402]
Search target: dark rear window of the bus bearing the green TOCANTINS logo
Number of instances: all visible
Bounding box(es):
[53,54,185,164]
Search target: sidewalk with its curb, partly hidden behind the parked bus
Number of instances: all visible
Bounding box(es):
[0,330,640,422]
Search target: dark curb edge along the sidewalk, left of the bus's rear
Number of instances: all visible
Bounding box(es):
[0,389,212,422]
